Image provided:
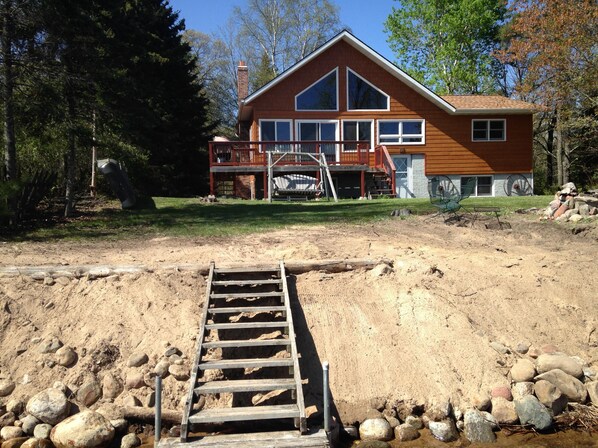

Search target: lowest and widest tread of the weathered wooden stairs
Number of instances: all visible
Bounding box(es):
[189,404,300,423]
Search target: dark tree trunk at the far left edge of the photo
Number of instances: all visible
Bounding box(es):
[2,0,17,180]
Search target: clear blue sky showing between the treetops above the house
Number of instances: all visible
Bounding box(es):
[170,0,396,61]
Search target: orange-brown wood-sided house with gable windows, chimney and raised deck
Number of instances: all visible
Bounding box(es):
[210,31,534,198]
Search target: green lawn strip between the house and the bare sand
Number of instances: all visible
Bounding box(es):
[11,196,552,241]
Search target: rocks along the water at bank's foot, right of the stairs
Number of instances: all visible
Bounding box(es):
[346,343,598,446]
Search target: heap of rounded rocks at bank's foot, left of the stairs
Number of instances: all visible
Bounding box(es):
[0,342,189,448]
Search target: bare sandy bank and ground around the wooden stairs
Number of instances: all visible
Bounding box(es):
[0,216,598,422]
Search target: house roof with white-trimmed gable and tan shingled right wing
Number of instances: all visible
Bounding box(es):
[239,30,535,116]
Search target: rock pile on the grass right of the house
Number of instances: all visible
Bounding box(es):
[544,182,598,222]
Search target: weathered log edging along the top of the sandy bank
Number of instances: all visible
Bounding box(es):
[0,258,392,280]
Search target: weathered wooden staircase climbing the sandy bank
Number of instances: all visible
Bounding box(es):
[181,262,307,442]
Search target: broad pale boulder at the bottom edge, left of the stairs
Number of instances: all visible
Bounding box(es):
[50,410,114,448]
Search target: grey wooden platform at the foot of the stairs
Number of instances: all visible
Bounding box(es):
[158,430,330,448]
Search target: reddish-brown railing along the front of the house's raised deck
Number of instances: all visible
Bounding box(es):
[210,140,370,167]
